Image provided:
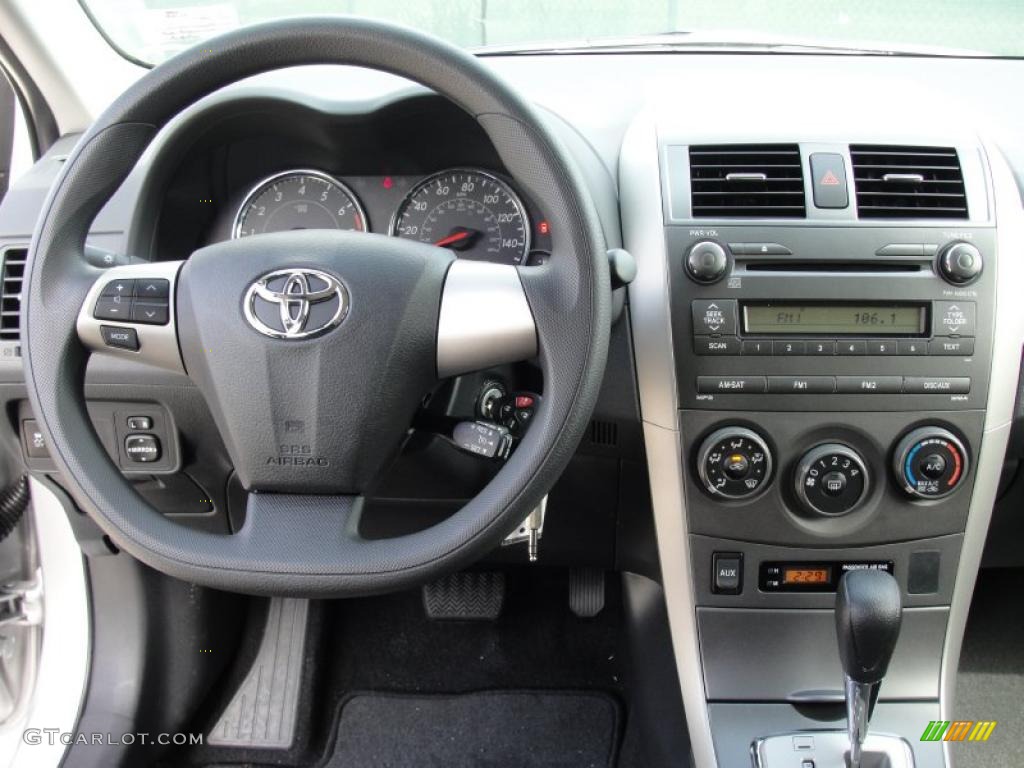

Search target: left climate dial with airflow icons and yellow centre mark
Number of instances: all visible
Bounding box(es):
[697,427,771,499]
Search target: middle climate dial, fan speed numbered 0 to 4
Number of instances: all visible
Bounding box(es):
[796,442,867,516]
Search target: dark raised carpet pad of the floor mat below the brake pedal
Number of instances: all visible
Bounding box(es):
[325,691,620,768]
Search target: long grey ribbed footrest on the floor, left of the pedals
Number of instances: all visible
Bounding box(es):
[206,597,309,750]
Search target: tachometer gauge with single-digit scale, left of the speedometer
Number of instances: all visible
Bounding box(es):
[231,171,367,238]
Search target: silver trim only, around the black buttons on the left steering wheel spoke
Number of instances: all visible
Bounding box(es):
[76,261,185,374]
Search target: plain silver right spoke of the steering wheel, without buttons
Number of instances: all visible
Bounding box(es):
[437,259,538,379]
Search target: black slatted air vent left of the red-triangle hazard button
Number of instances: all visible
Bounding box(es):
[690,144,806,218]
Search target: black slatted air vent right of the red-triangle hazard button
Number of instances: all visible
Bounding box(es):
[850,144,968,219]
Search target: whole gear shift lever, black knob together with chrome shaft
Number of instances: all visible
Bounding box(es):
[836,569,903,768]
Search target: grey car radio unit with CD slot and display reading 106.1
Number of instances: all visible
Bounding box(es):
[667,226,994,411]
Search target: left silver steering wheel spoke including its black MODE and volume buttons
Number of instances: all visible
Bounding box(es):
[76,261,185,374]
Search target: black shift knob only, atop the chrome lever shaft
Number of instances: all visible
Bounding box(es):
[836,569,903,685]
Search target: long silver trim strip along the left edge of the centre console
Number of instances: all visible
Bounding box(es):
[618,111,717,768]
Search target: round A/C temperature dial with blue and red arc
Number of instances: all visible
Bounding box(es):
[893,427,968,499]
